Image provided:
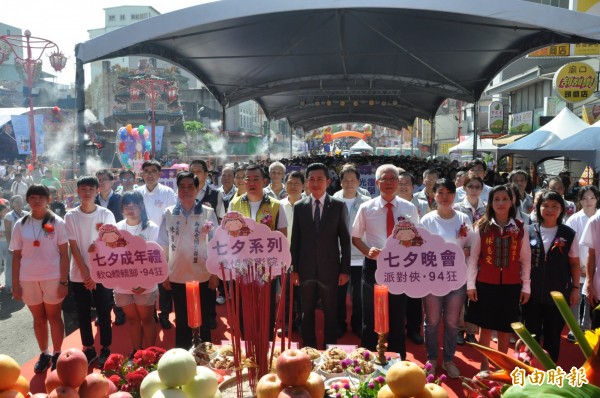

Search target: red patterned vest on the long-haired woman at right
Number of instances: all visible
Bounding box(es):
[477,220,524,285]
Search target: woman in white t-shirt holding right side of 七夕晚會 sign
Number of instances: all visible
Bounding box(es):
[421,178,473,378]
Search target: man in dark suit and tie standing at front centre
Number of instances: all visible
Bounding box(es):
[291,163,351,347]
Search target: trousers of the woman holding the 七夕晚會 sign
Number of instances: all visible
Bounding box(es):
[423,285,467,362]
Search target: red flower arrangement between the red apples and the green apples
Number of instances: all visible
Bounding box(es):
[102,347,166,398]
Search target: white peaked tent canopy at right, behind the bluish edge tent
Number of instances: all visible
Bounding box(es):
[498,108,589,163]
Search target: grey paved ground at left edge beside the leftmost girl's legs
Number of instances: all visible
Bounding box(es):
[0,290,76,365]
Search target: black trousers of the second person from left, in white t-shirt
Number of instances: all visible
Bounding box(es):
[72,282,113,347]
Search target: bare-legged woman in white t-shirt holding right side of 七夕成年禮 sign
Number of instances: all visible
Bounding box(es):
[114,191,158,355]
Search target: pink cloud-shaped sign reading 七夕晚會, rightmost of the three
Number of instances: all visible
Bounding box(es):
[375,220,467,298]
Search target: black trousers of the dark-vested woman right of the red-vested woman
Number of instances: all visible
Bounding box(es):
[522,301,565,362]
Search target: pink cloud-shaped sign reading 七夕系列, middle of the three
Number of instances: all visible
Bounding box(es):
[206,212,292,280]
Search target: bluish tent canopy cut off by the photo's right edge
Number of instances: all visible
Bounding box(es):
[537,121,600,171]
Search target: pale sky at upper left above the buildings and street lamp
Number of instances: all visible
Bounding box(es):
[0,0,213,85]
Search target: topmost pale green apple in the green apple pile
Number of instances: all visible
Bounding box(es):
[157,348,196,387]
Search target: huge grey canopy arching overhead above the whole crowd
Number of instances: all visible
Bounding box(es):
[76,0,600,130]
